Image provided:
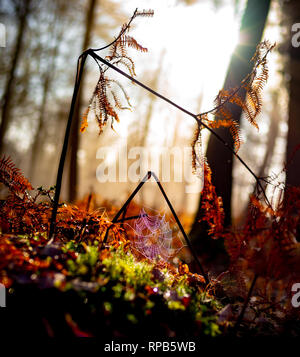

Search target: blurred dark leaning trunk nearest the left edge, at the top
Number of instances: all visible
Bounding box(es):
[0,0,31,154]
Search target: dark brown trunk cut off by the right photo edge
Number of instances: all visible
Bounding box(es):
[285,0,300,186]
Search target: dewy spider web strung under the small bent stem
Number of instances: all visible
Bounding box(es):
[132,208,184,261]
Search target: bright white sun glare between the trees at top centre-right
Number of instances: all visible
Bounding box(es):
[118,0,240,139]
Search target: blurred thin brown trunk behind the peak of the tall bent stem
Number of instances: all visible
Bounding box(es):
[68,0,96,202]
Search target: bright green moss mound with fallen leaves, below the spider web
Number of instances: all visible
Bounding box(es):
[2,238,222,336]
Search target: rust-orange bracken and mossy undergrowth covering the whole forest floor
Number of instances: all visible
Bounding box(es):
[0,159,300,337]
